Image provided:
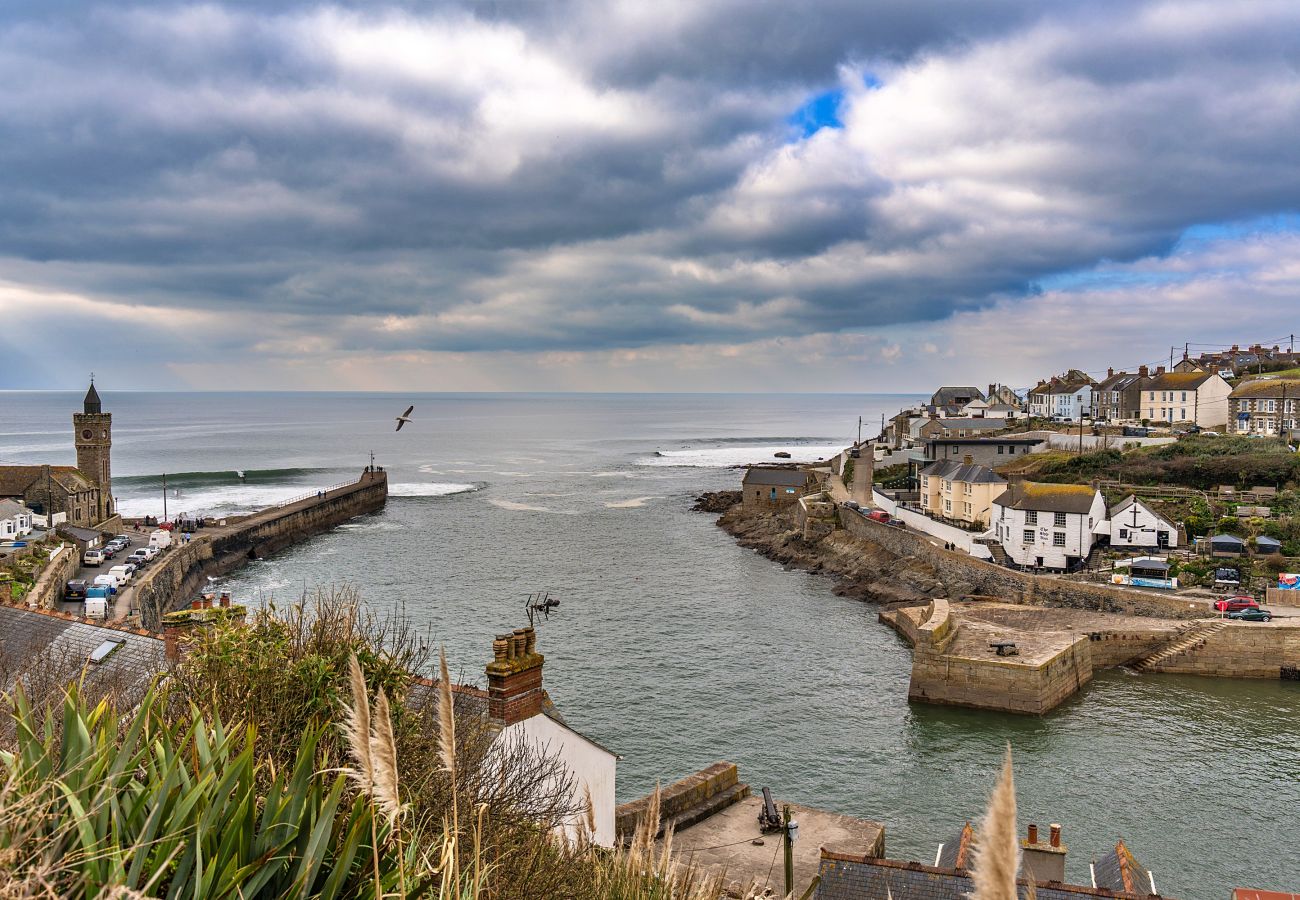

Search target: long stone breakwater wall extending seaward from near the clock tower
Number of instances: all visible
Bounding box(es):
[135,471,389,631]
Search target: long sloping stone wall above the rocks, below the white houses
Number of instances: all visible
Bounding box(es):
[840,510,1205,619]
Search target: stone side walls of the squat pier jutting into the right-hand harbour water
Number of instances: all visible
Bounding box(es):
[907,637,1092,715]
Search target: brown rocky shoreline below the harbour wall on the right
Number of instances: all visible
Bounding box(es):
[693,499,948,603]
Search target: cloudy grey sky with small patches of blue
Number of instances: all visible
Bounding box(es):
[0,0,1300,391]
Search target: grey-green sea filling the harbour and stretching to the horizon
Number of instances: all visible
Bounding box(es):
[0,390,1300,900]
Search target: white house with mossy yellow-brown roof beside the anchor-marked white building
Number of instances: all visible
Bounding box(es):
[987,481,1106,568]
